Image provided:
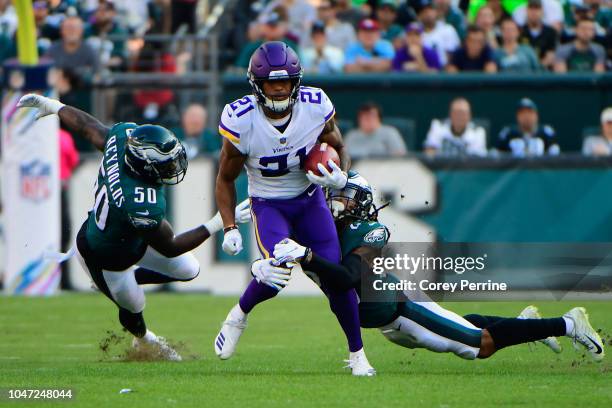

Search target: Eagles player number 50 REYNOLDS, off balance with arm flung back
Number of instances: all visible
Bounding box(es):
[18,94,250,360]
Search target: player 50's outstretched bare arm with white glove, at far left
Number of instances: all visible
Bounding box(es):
[17,94,109,151]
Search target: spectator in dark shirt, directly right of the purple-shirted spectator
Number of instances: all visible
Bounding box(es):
[446,26,497,73]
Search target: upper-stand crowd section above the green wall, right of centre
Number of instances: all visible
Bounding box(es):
[228,0,612,73]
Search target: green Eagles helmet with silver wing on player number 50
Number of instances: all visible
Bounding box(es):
[125,125,187,184]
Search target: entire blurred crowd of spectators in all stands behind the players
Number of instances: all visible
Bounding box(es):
[0,0,612,158]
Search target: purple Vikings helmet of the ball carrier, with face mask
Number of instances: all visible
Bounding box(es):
[247,41,303,113]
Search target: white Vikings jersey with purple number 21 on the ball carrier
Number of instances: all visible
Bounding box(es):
[219,86,335,199]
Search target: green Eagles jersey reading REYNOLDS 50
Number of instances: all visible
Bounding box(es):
[85,123,166,270]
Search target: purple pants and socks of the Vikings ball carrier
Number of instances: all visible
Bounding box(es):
[240,185,363,351]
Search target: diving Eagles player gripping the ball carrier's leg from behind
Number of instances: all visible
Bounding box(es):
[270,172,604,361]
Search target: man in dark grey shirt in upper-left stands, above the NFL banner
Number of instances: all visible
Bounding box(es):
[47,16,99,82]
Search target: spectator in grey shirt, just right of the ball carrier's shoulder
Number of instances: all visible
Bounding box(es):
[345,103,406,159]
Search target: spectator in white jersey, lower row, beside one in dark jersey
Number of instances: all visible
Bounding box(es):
[425,96,487,156]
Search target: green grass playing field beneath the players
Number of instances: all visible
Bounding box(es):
[0,294,612,408]
